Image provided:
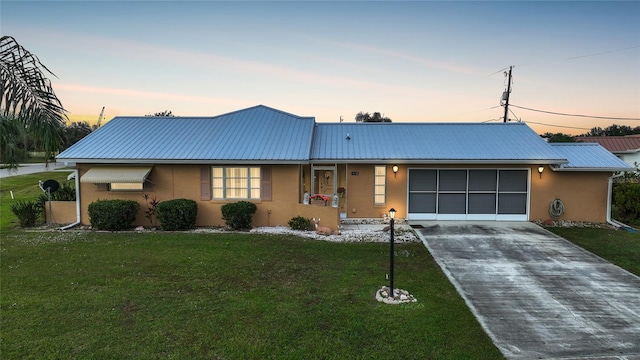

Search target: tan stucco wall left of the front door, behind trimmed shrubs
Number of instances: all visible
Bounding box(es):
[79,164,339,230]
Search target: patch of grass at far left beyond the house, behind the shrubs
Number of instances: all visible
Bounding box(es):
[0,169,75,232]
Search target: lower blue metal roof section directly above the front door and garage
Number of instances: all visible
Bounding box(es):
[311,123,566,164]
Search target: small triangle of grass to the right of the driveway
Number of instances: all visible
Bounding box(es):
[547,227,640,276]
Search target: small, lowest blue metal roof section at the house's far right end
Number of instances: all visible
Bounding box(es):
[549,142,635,171]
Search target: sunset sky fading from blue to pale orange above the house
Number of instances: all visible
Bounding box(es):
[0,0,640,134]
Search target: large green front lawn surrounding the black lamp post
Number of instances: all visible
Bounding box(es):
[0,230,502,359]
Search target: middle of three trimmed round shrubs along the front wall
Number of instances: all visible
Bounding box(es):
[155,199,198,231]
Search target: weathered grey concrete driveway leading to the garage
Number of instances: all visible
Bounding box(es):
[417,222,640,360]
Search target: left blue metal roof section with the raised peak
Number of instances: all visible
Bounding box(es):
[58,105,315,163]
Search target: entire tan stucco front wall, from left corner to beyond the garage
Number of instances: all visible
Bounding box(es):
[76,163,611,230]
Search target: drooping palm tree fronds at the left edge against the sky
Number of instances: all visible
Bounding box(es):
[0,36,67,168]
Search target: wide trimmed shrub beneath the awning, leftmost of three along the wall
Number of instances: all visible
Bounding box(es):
[89,200,140,231]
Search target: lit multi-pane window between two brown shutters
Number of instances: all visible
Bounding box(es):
[212,167,260,199]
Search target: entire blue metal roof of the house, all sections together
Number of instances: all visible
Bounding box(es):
[58,105,633,171]
